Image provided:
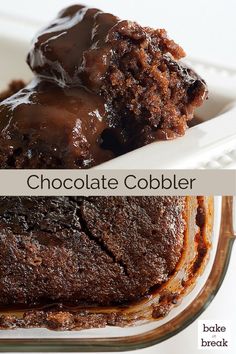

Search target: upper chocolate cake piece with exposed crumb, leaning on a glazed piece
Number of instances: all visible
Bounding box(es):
[28,5,207,147]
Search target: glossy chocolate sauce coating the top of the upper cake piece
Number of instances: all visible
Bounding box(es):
[27,5,119,91]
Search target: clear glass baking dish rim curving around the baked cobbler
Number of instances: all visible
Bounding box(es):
[0,197,236,352]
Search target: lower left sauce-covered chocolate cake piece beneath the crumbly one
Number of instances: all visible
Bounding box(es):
[0,80,114,168]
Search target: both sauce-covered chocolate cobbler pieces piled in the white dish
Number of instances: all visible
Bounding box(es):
[0,5,207,168]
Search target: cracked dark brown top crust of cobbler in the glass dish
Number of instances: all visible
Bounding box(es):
[0,197,185,306]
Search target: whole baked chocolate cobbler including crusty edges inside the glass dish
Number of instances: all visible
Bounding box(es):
[0,197,212,330]
